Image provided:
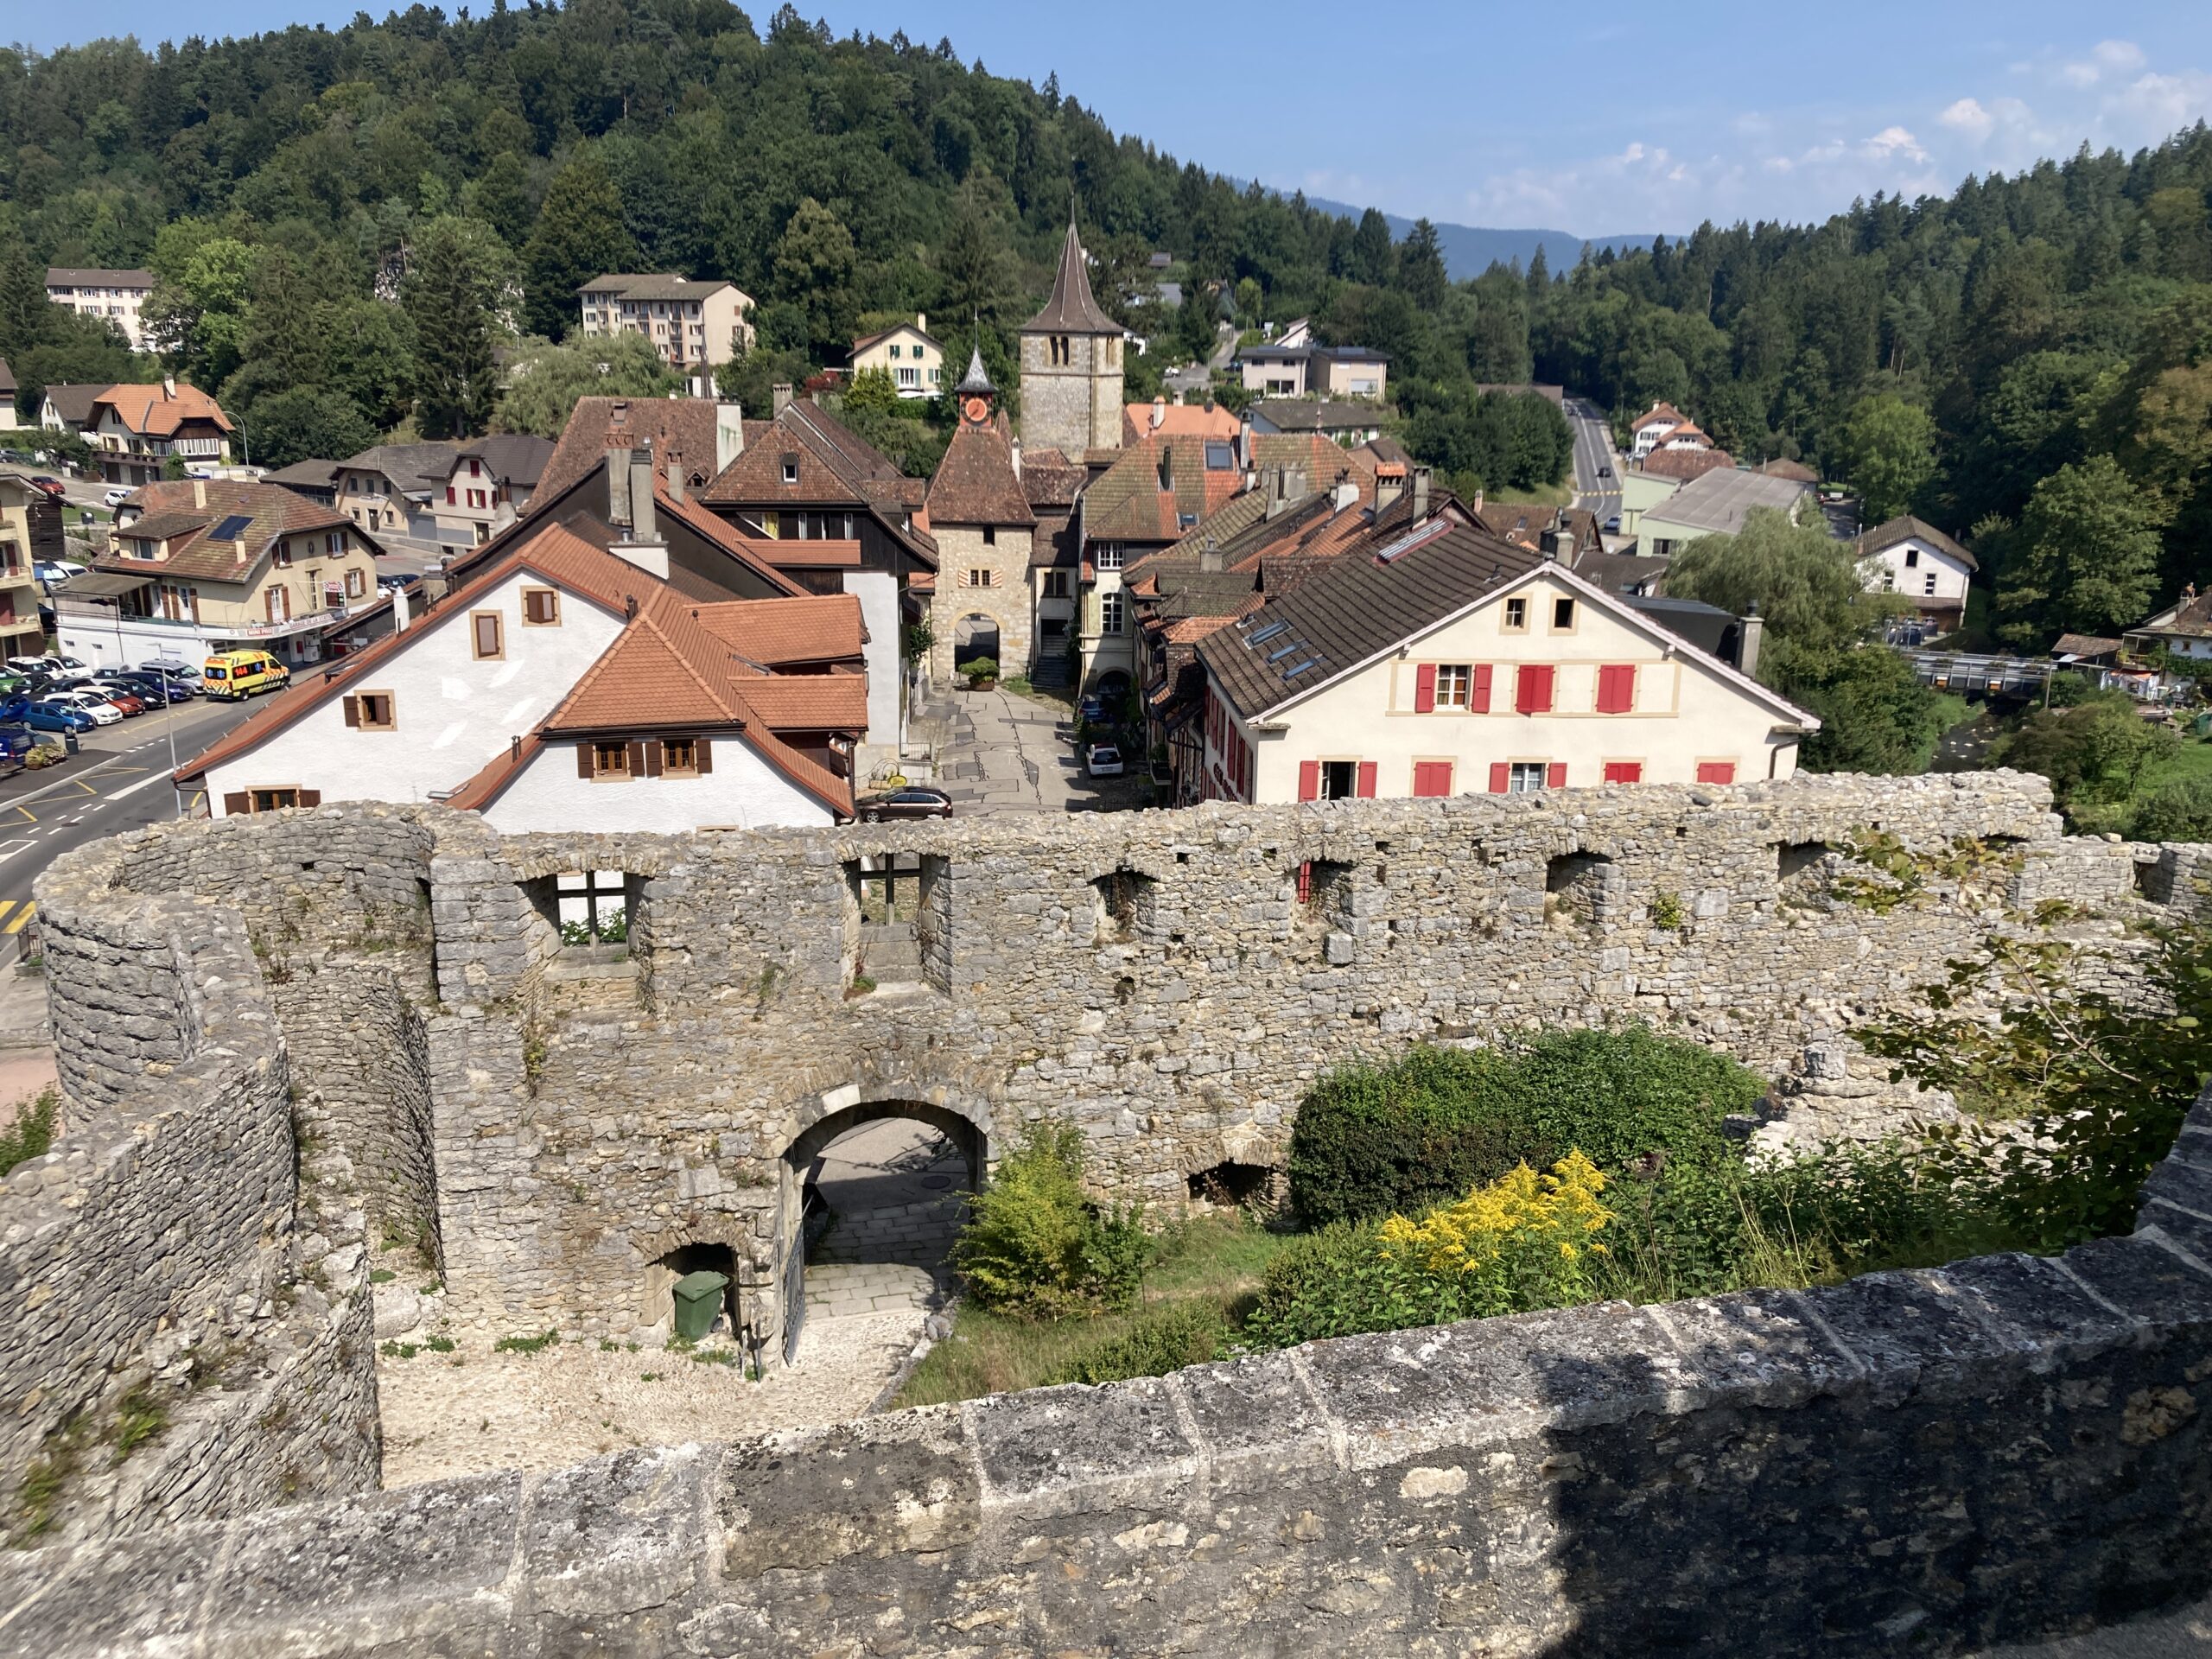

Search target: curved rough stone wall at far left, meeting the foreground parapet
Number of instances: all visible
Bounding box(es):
[0,847,378,1540]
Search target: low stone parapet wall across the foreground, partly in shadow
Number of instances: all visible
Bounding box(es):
[0,1103,2212,1659]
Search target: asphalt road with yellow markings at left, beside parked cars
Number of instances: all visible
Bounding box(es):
[0,702,259,960]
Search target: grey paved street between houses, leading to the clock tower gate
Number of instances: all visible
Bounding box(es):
[912,690,1153,814]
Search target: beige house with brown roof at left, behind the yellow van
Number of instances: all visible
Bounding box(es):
[55,478,391,668]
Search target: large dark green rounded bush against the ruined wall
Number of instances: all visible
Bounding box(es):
[1289,1027,1761,1225]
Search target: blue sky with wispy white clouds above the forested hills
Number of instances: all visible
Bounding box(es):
[17,0,2212,237]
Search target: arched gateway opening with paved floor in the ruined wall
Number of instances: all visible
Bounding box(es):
[783,1099,984,1360]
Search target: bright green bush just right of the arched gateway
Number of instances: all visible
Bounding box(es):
[953,1123,1148,1319]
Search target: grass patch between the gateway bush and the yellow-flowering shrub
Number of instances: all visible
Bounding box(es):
[893,1212,1287,1407]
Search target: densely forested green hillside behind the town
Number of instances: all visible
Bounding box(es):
[0,0,2212,639]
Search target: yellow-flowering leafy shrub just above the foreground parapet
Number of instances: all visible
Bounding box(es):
[1245,1153,1612,1347]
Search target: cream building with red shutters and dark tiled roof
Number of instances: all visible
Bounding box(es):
[1199,520,1821,803]
